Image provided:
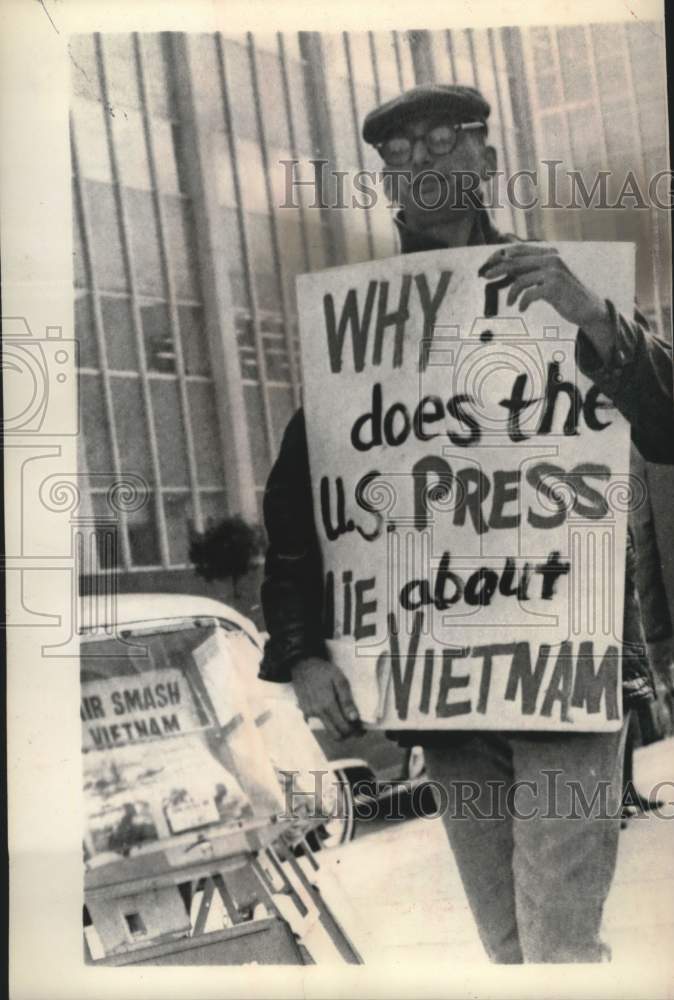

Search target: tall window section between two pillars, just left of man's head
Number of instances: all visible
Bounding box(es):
[210,35,318,501]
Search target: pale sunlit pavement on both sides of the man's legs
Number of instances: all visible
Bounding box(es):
[321,739,674,968]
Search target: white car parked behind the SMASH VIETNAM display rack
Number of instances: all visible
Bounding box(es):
[80,593,424,849]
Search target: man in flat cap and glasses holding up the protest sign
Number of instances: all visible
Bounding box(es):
[261,85,674,963]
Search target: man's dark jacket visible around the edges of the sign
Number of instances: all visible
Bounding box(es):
[260,212,674,732]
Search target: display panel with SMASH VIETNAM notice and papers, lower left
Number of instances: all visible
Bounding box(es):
[80,619,280,865]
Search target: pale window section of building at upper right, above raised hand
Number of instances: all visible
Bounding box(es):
[509,23,671,329]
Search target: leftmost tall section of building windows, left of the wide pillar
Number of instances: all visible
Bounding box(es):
[70,34,226,571]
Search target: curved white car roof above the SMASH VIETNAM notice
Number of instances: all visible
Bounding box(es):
[80,593,261,641]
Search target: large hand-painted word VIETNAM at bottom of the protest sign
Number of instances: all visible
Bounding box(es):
[380,612,620,723]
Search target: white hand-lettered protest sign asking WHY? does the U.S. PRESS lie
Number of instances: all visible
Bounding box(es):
[297,243,639,731]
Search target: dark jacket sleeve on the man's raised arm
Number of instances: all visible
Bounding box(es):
[576,300,674,465]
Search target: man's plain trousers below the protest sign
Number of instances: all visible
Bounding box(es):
[424,725,626,964]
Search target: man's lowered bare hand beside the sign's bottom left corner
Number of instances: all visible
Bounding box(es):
[291,656,363,740]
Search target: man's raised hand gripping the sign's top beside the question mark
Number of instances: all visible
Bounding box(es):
[478,243,613,360]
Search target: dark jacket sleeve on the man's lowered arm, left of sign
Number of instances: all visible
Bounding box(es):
[259,410,328,681]
